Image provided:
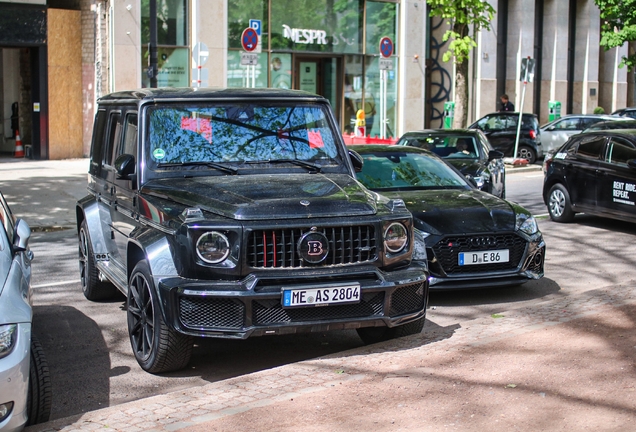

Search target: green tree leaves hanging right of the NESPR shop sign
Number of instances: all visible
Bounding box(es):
[427,0,496,63]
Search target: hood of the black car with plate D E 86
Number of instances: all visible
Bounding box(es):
[381,189,516,234]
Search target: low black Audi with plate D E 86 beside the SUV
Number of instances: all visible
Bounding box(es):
[355,145,545,290]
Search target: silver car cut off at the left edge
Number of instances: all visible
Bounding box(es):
[0,193,51,431]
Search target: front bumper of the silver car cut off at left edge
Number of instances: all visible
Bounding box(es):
[0,323,31,432]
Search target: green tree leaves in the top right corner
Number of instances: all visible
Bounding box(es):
[594,0,636,71]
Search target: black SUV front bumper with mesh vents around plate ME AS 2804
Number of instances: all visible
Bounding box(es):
[157,265,428,339]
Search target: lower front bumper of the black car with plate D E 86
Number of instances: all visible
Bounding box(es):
[429,237,546,291]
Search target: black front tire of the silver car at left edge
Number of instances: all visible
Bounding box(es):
[26,337,51,426]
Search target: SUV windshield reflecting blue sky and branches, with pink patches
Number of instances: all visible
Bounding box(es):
[148,103,338,166]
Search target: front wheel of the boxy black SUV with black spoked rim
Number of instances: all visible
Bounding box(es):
[126,260,193,374]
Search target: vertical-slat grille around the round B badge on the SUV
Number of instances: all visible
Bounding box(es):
[247,225,377,268]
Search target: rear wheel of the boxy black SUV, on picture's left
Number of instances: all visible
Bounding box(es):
[79,220,119,301]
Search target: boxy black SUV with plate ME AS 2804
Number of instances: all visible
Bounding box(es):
[77,88,428,373]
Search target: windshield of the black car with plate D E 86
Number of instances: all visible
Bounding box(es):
[356,151,469,190]
